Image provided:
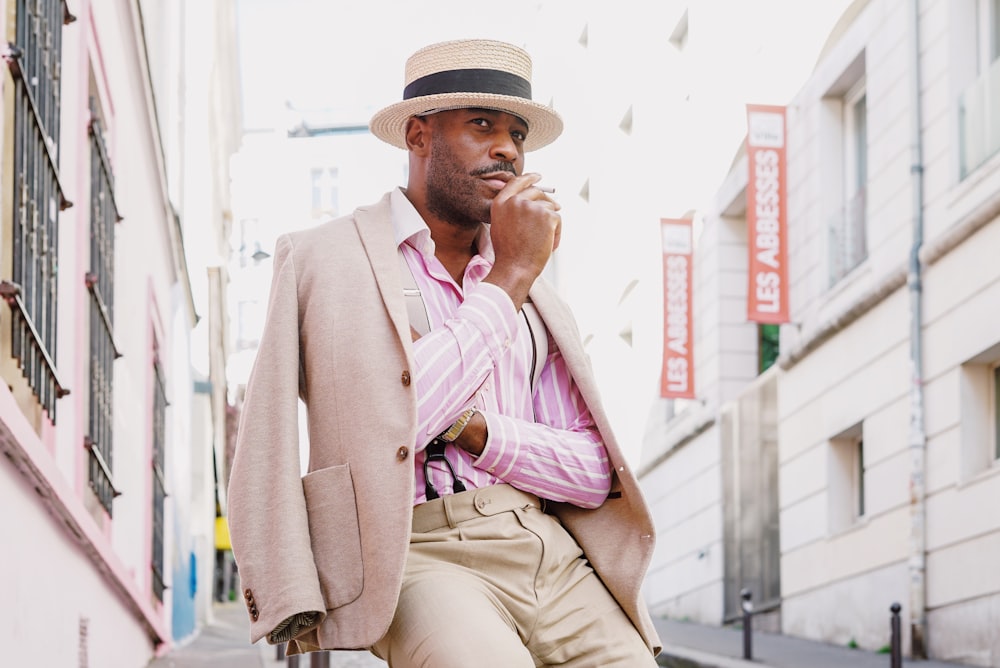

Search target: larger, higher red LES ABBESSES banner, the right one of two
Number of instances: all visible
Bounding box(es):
[747,104,789,324]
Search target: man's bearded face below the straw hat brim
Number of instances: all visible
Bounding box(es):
[427,109,528,227]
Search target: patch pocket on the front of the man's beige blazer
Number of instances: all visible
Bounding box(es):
[302,464,364,610]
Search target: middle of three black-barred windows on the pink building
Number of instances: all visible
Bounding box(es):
[84,98,121,516]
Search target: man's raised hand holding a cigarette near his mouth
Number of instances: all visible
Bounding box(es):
[484,174,562,310]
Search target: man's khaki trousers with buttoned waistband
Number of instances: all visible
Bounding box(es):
[372,485,656,668]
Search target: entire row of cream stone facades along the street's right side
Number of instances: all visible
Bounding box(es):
[642,0,1000,666]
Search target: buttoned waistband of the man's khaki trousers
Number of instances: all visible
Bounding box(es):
[413,483,545,533]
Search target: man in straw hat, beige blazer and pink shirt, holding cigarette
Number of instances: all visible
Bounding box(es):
[229,40,659,668]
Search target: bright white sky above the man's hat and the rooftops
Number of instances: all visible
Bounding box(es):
[236,0,851,215]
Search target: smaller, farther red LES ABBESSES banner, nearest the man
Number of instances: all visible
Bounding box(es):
[660,218,694,399]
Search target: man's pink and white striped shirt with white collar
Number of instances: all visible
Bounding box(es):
[392,189,611,508]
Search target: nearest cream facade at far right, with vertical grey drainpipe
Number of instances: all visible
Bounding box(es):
[778,0,1000,666]
